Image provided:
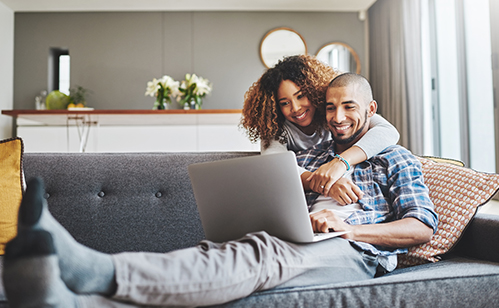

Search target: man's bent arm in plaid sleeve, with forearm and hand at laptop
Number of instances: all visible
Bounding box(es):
[311,148,438,247]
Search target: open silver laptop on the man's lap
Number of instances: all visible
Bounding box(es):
[188,151,346,243]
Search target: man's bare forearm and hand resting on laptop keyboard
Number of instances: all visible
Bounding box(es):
[310,210,433,248]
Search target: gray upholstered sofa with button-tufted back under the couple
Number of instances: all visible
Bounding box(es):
[0,152,499,308]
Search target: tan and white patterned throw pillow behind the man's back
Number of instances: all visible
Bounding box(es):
[398,157,499,267]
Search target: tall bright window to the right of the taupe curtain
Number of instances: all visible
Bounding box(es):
[422,0,496,172]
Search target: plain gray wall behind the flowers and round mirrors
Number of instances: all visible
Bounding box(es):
[14,12,366,109]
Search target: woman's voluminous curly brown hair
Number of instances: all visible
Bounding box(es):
[240,55,339,147]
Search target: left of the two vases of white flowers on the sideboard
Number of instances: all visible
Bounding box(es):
[145,75,180,110]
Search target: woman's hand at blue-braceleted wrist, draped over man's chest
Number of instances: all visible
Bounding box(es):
[306,159,347,196]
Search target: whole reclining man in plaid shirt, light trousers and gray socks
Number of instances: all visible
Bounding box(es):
[3,75,437,308]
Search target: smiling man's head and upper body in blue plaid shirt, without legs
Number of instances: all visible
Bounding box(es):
[297,74,437,271]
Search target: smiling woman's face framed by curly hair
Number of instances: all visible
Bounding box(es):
[277,80,316,134]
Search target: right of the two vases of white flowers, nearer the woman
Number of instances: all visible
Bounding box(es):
[177,74,212,109]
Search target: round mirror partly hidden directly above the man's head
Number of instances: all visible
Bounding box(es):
[317,42,360,74]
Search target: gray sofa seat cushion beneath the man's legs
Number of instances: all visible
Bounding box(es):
[212,258,499,308]
